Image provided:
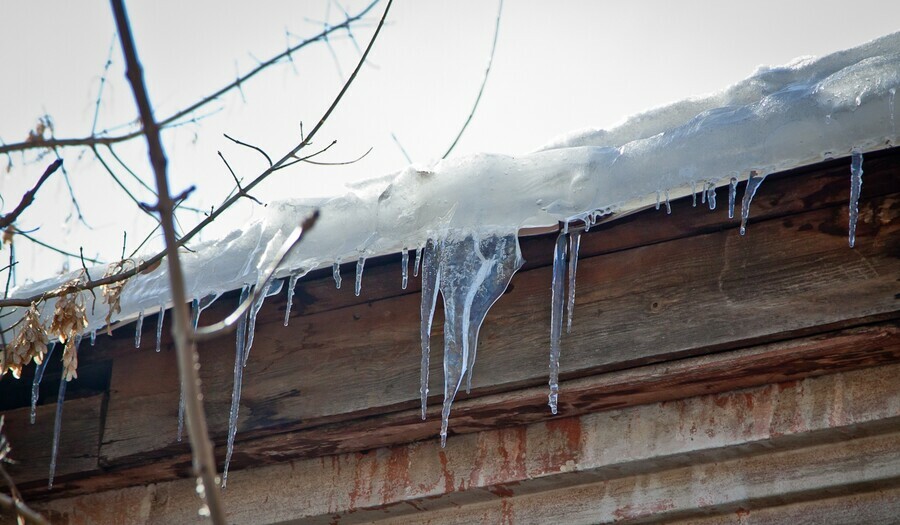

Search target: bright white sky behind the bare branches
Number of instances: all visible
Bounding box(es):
[0,0,900,282]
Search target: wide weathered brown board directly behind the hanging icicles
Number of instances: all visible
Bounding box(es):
[101,191,900,465]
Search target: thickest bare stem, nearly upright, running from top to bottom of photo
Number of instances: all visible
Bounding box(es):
[111,0,226,525]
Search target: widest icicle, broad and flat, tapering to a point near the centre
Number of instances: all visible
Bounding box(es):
[439,234,522,446]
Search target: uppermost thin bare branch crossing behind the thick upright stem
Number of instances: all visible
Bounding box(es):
[0,0,380,155]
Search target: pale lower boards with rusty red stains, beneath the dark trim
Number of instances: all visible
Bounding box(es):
[24,365,900,525]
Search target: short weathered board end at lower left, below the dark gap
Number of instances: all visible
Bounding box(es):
[4,394,106,486]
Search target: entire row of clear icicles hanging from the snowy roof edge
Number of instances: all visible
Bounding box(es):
[30,149,863,488]
